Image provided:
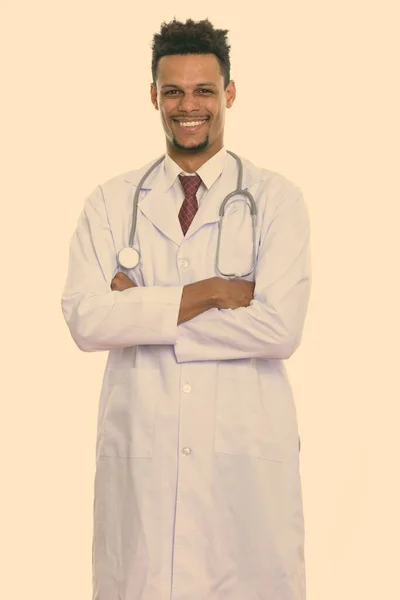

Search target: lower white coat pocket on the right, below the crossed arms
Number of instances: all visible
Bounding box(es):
[214,369,284,462]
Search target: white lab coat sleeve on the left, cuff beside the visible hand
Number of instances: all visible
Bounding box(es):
[61,187,183,352]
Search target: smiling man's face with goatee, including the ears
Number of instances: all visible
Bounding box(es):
[151,54,236,154]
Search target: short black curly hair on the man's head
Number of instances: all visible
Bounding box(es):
[151,18,231,89]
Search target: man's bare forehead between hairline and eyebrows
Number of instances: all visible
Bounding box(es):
[157,54,223,86]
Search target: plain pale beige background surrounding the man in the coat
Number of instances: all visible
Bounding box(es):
[0,0,400,600]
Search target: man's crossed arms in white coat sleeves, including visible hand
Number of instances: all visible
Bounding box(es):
[62,183,311,362]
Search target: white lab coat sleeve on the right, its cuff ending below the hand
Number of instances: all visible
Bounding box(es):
[175,186,311,363]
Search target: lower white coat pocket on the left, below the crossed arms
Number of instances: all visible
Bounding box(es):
[99,368,160,458]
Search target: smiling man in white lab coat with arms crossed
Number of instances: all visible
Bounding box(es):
[62,20,310,600]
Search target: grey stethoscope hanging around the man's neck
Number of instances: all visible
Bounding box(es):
[118,150,257,279]
